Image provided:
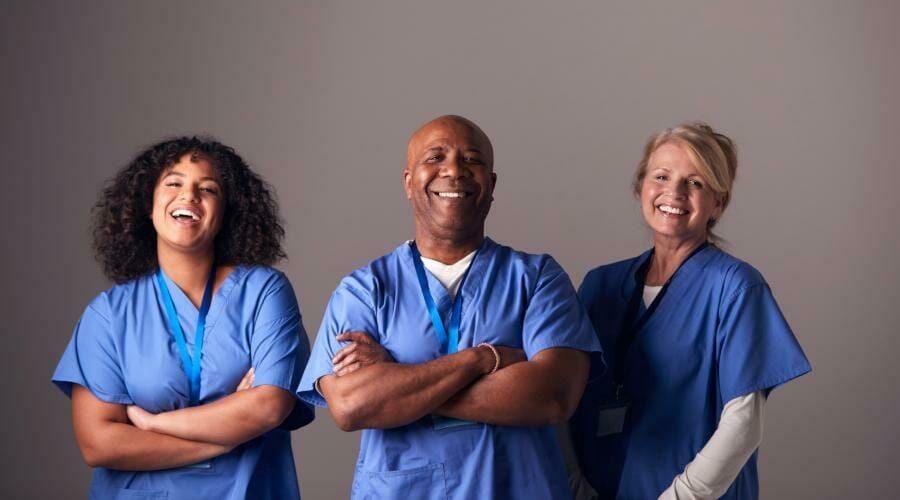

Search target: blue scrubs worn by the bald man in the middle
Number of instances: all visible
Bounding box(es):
[298,239,599,500]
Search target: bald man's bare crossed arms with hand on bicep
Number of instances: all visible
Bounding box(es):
[319,332,590,431]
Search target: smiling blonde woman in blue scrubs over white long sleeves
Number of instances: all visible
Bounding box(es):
[564,123,810,499]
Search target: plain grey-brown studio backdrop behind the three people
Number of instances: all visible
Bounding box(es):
[0,0,900,499]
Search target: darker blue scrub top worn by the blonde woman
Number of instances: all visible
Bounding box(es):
[572,245,810,499]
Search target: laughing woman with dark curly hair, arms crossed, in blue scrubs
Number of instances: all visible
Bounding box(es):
[53,137,313,498]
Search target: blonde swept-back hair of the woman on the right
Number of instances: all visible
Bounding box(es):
[632,122,737,242]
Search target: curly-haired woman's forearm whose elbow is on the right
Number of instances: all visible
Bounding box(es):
[142,385,295,446]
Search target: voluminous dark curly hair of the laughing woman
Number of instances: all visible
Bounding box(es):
[93,136,285,283]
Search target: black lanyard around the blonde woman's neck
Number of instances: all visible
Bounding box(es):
[613,242,709,401]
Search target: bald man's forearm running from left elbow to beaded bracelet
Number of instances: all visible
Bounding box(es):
[320,348,494,431]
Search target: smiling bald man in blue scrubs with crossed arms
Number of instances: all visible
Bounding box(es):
[297,116,600,500]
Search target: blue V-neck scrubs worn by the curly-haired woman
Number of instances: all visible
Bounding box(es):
[53,266,313,500]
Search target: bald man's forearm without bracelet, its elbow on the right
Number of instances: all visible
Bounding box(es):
[434,349,589,426]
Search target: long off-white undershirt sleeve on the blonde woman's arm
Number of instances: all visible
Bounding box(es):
[659,392,766,500]
